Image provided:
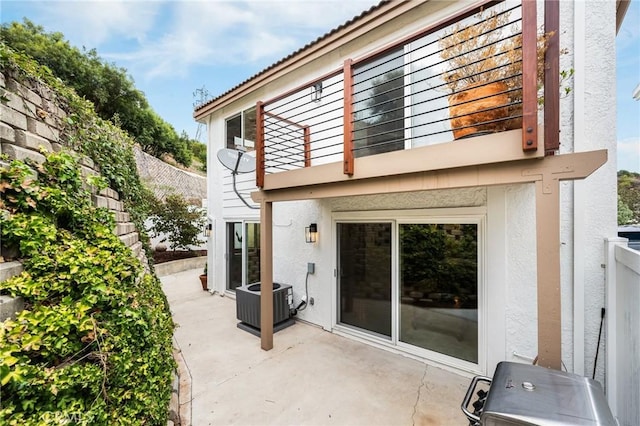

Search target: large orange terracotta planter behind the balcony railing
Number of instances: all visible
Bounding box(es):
[449,82,513,139]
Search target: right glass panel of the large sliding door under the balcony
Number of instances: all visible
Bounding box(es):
[399,223,478,363]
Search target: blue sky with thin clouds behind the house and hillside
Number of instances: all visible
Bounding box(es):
[0,0,640,172]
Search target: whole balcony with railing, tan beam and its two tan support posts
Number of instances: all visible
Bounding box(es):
[251,0,607,370]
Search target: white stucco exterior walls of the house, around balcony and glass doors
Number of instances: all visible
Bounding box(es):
[202,1,616,382]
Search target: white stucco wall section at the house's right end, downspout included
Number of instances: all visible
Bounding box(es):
[560,1,617,384]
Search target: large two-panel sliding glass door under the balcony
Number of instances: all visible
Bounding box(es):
[336,220,481,364]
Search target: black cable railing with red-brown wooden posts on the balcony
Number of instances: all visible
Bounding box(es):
[257,0,558,187]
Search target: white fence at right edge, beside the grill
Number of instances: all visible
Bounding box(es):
[606,238,640,426]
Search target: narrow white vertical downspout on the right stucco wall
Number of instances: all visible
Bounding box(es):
[572,2,587,376]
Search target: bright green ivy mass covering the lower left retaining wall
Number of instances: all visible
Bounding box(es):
[0,152,175,425]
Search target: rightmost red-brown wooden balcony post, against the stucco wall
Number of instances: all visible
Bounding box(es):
[544,0,560,155]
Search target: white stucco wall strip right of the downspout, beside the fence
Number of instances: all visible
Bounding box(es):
[575,1,617,381]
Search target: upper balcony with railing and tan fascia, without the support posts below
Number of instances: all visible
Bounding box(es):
[256,0,559,191]
